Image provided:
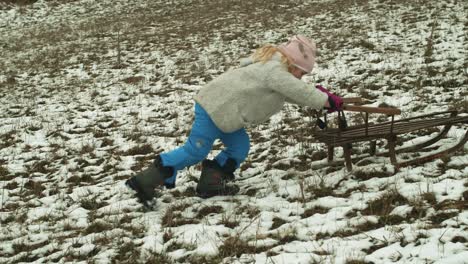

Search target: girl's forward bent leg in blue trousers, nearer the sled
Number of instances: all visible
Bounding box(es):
[216,128,250,168]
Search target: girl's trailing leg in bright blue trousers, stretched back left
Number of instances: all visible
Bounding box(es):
[161,104,222,186]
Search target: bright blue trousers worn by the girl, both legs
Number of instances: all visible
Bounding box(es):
[161,103,250,184]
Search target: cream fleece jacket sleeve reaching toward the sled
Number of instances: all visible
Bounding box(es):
[268,67,328,109]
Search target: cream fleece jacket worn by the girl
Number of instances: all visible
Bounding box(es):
[194,54,328,133]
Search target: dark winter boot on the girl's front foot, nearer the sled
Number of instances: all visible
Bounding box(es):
[197,159,239,198]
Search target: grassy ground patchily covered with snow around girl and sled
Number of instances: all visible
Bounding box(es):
[0,0,468,264]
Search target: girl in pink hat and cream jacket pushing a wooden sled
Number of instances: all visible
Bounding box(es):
[126,35,343,206]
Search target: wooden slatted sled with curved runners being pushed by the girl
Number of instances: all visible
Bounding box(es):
[313,98,468,171]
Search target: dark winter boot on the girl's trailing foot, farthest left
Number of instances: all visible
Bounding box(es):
[125,156,174,207]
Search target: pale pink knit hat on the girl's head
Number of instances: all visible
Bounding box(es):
[278,35,317,72]
